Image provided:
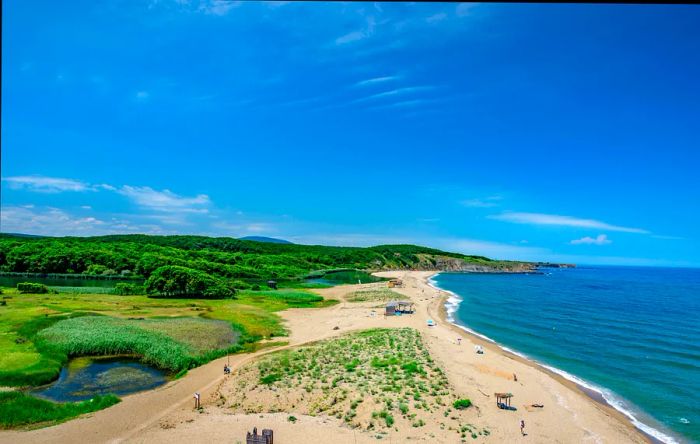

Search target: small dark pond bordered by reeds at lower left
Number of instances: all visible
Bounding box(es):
[31,357,168,402]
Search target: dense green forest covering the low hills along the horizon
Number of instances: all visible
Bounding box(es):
[0,234,518,288]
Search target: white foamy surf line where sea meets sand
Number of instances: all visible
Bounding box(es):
[428,275,681,444]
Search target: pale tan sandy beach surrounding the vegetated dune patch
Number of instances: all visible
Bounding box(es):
[0,271,648,444]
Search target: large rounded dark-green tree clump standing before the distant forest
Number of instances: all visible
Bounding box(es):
[144,265,236,299]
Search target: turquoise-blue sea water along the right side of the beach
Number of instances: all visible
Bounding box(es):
[433,267,700,442]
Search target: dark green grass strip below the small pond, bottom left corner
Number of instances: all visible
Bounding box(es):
[0,391,120,429]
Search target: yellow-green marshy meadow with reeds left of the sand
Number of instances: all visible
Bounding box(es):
[0,289,334,386]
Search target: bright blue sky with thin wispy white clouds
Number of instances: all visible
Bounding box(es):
[0,0,700,266]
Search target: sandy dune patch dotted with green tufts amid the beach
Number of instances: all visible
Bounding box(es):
[222,328,489,440]
